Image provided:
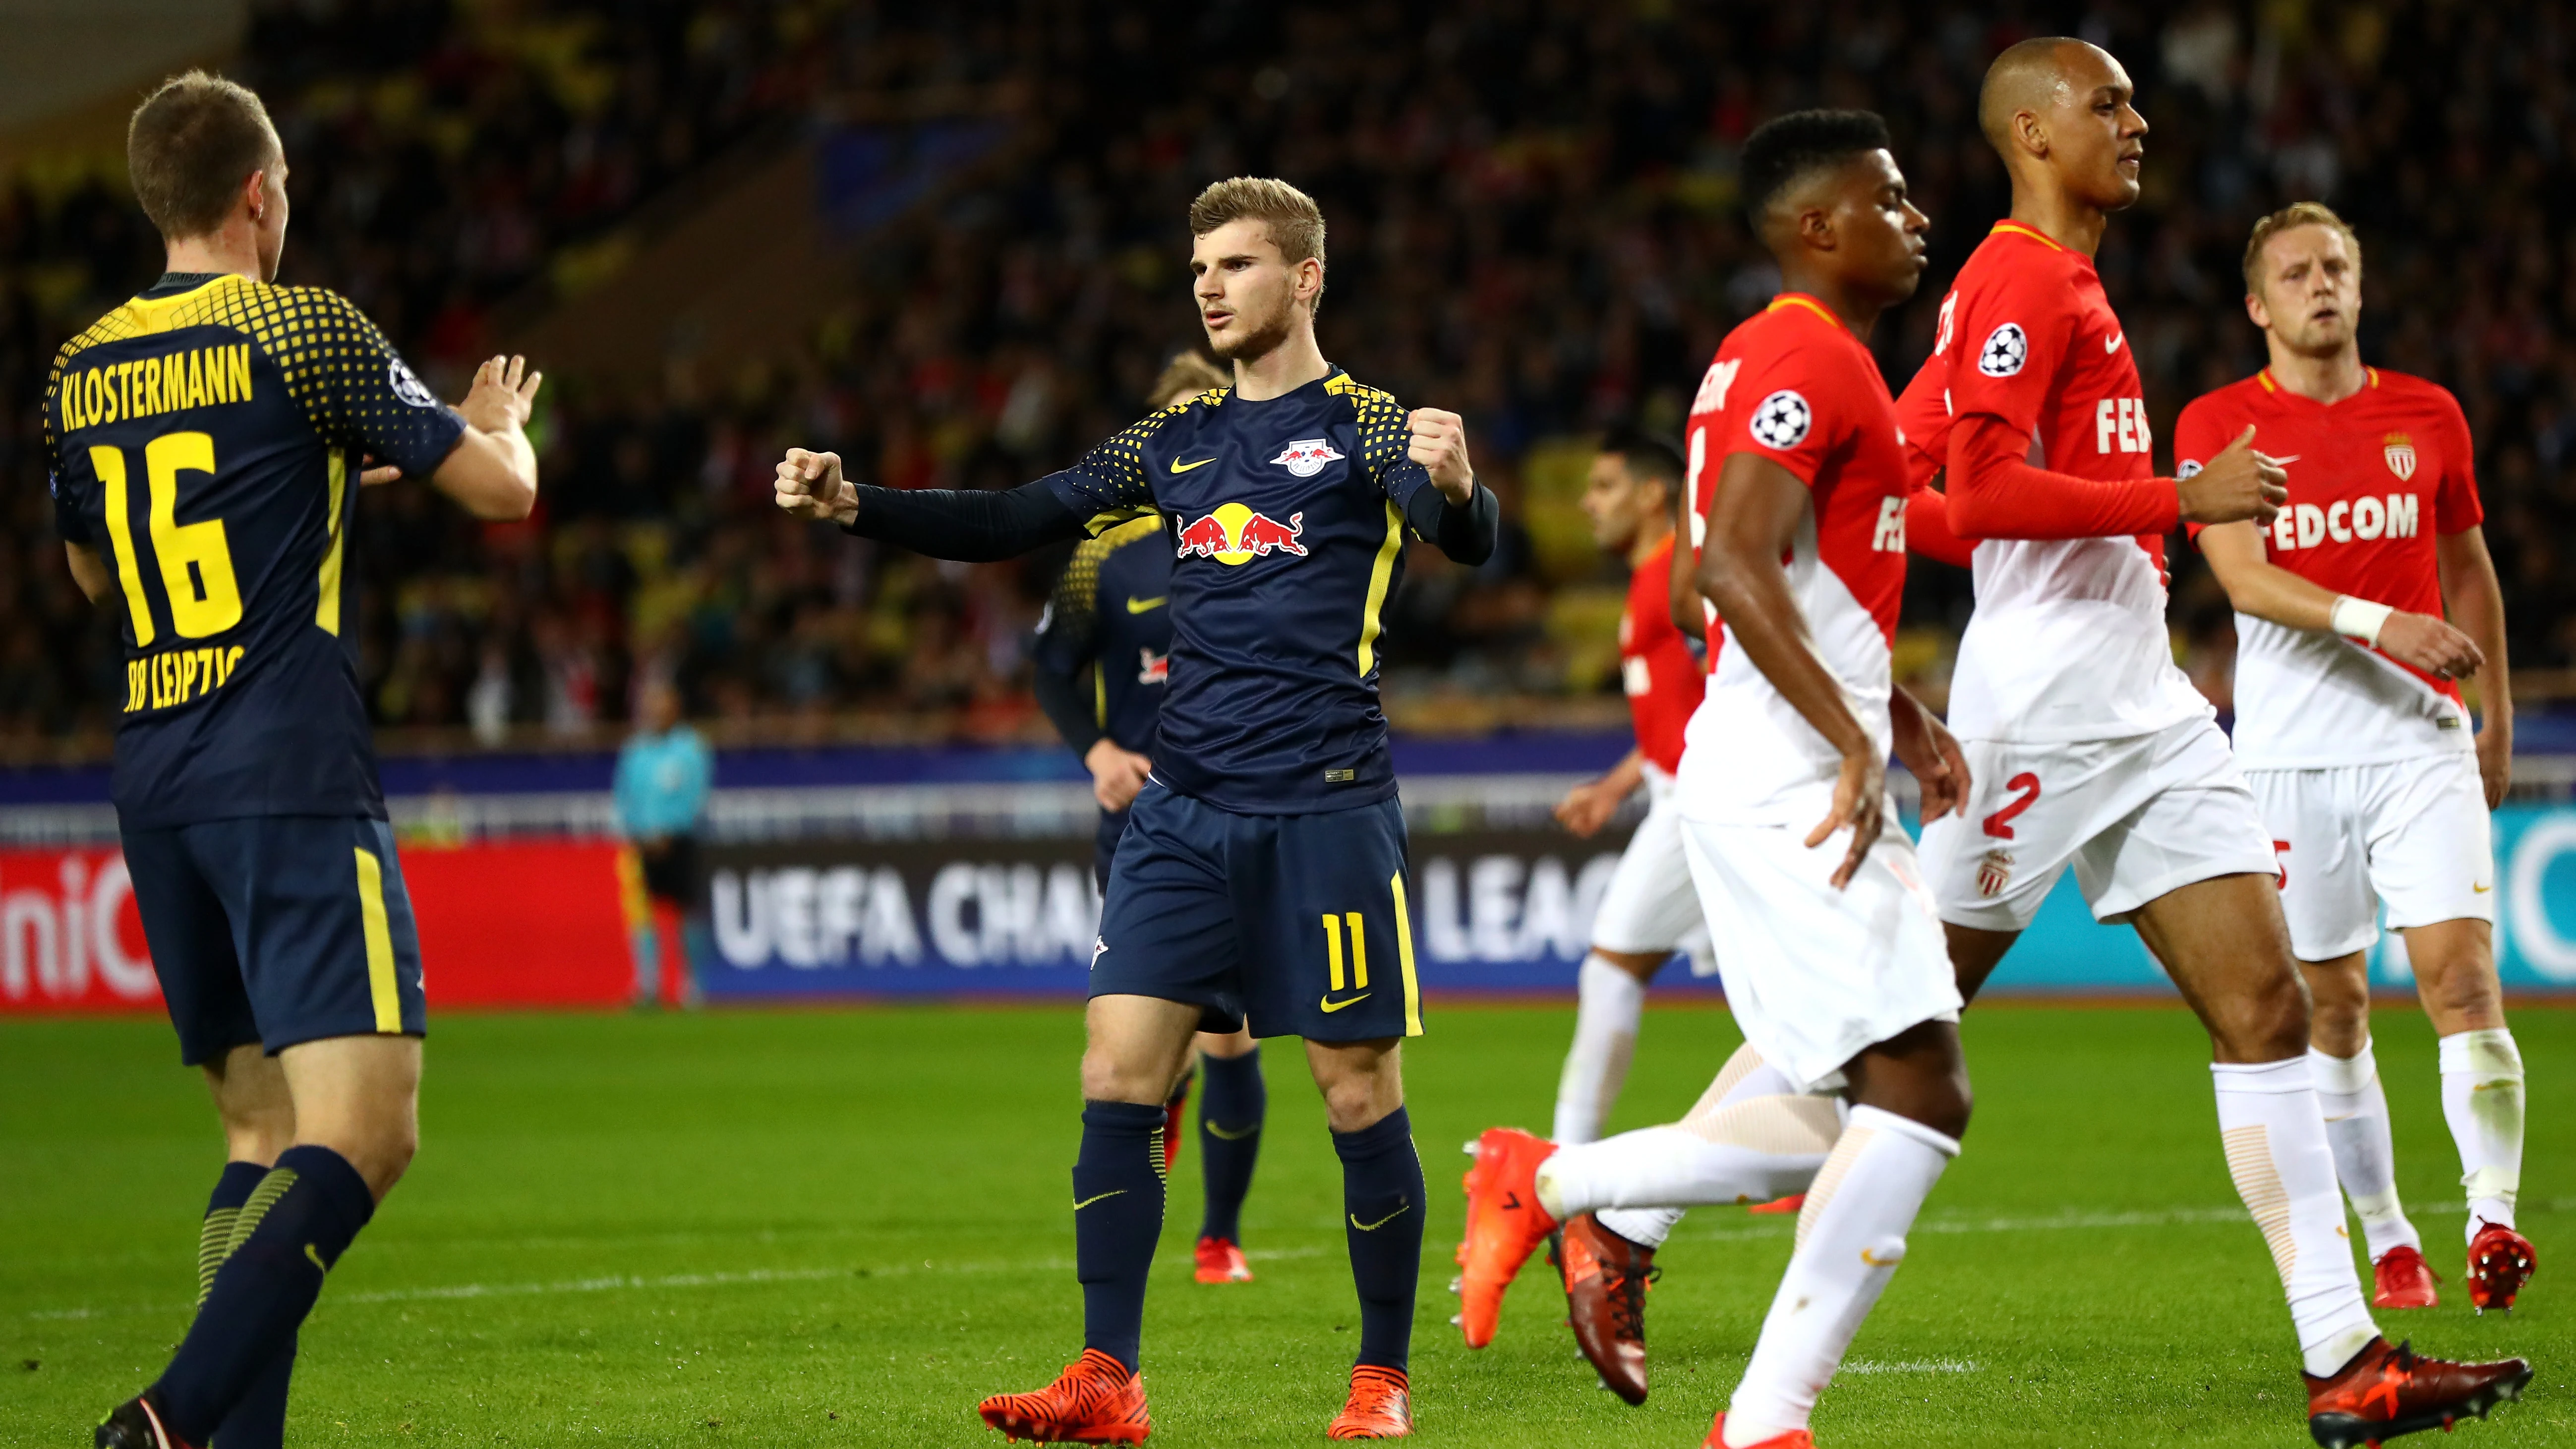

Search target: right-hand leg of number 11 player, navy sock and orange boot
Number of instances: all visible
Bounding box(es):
[1306,1037,1424,1439]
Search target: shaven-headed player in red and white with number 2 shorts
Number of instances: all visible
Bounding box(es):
[1898,39,2529,1444]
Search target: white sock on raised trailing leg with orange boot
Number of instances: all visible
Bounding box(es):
[1538,1097,1839,1238]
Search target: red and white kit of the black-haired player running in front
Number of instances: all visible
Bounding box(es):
[1680,293,1960,1089]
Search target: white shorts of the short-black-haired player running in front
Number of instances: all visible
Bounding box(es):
[1682,806,1960,1091]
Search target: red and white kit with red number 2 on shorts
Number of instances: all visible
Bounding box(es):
[1898,221,2272,931]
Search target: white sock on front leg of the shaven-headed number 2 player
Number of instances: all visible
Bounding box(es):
[2210,1055,2380,1377]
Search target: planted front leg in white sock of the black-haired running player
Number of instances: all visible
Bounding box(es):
[1708,1022,1973,1449]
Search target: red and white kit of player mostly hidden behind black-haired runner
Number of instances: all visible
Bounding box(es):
[1592,538,1716,976]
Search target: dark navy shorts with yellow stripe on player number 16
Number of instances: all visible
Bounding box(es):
[123,816,428,1065]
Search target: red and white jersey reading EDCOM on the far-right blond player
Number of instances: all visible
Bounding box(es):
[2174,368,2486,769]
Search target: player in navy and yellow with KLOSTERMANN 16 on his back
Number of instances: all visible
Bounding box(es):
[44,72,538,1449]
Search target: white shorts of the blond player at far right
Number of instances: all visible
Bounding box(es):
[2246,752,2496,960]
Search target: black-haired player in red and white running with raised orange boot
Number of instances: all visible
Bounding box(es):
[1468,111,1968,1449]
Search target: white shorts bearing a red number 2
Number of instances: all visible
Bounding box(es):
[1924,718,2275,931]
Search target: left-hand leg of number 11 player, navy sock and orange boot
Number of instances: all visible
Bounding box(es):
[976,996,1198,1444]
